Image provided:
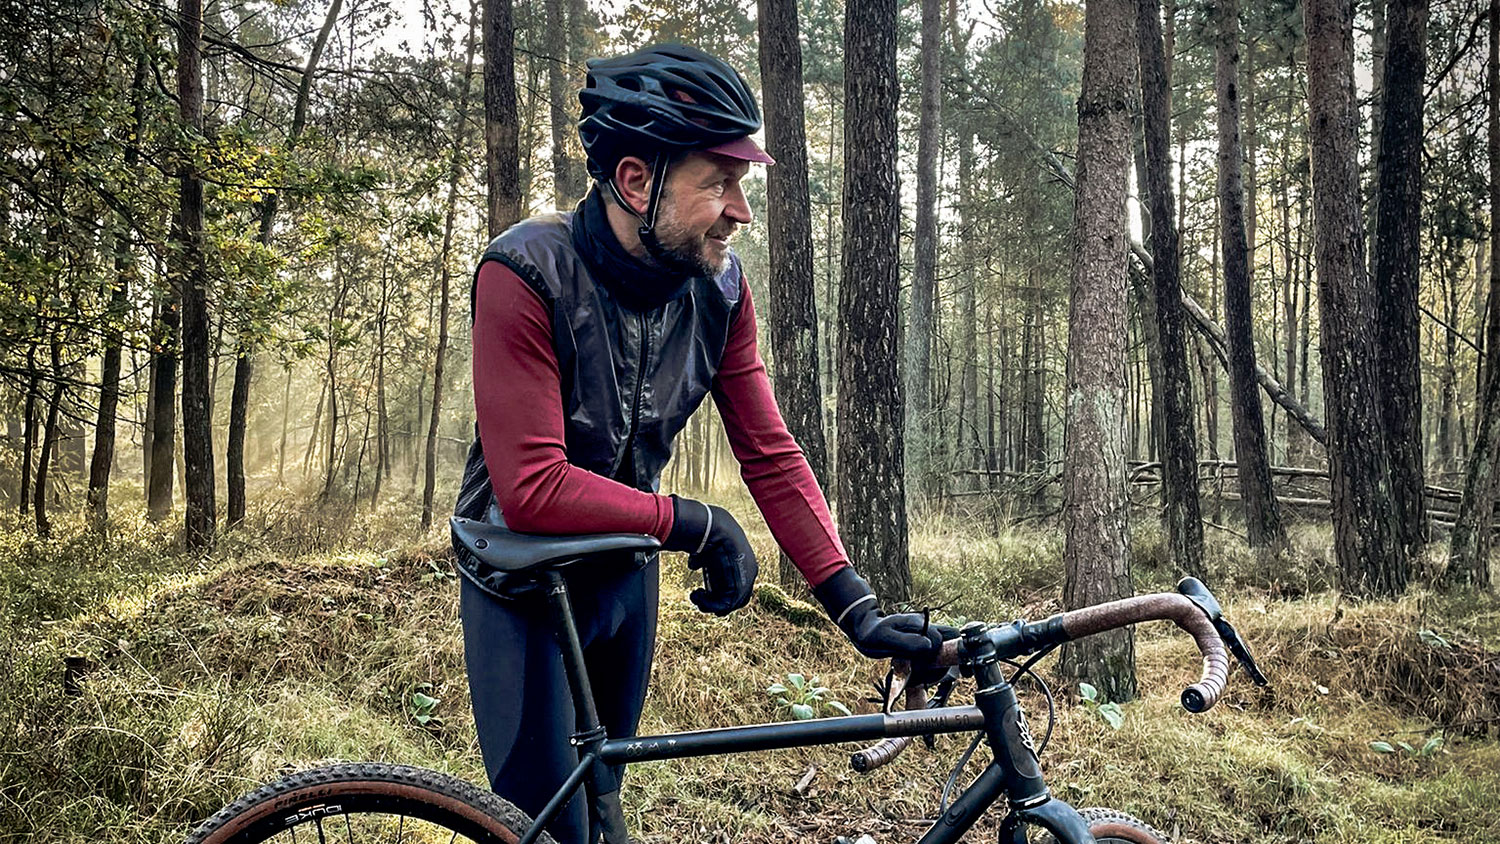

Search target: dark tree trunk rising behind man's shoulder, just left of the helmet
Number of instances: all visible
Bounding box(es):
[489,0,522,238]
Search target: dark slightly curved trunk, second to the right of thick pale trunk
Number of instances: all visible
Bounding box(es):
[1215,0,1286,552]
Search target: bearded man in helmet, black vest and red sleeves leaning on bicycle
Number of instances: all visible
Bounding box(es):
[456,45,942,844]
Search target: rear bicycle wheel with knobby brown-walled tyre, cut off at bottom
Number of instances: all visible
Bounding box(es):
[188,763,554,844]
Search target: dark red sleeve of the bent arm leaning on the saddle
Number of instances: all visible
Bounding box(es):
[473,261,672,540]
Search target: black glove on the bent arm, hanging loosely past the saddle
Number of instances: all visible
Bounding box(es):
[662,495,761,616]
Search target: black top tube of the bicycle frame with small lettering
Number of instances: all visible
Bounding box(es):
[599,706,984,765]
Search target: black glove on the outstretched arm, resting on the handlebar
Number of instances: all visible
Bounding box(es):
[813,565,959,663]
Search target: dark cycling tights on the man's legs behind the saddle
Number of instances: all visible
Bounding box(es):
[459,561,659,844]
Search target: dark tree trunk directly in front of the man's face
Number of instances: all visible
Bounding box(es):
[756,0,828,591]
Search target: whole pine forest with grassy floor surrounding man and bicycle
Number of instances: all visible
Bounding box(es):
[0,0,1500,844]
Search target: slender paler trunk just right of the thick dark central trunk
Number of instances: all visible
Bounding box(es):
[900,0,942,501]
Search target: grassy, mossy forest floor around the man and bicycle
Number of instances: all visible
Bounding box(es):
[0,499,1500,844]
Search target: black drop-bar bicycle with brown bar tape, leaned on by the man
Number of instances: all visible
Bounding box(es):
[188,519,1268,844]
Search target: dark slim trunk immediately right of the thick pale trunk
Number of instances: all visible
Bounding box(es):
[1137,0,1205,577]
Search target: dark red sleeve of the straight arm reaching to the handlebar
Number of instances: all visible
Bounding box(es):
[714,278,849,586]
